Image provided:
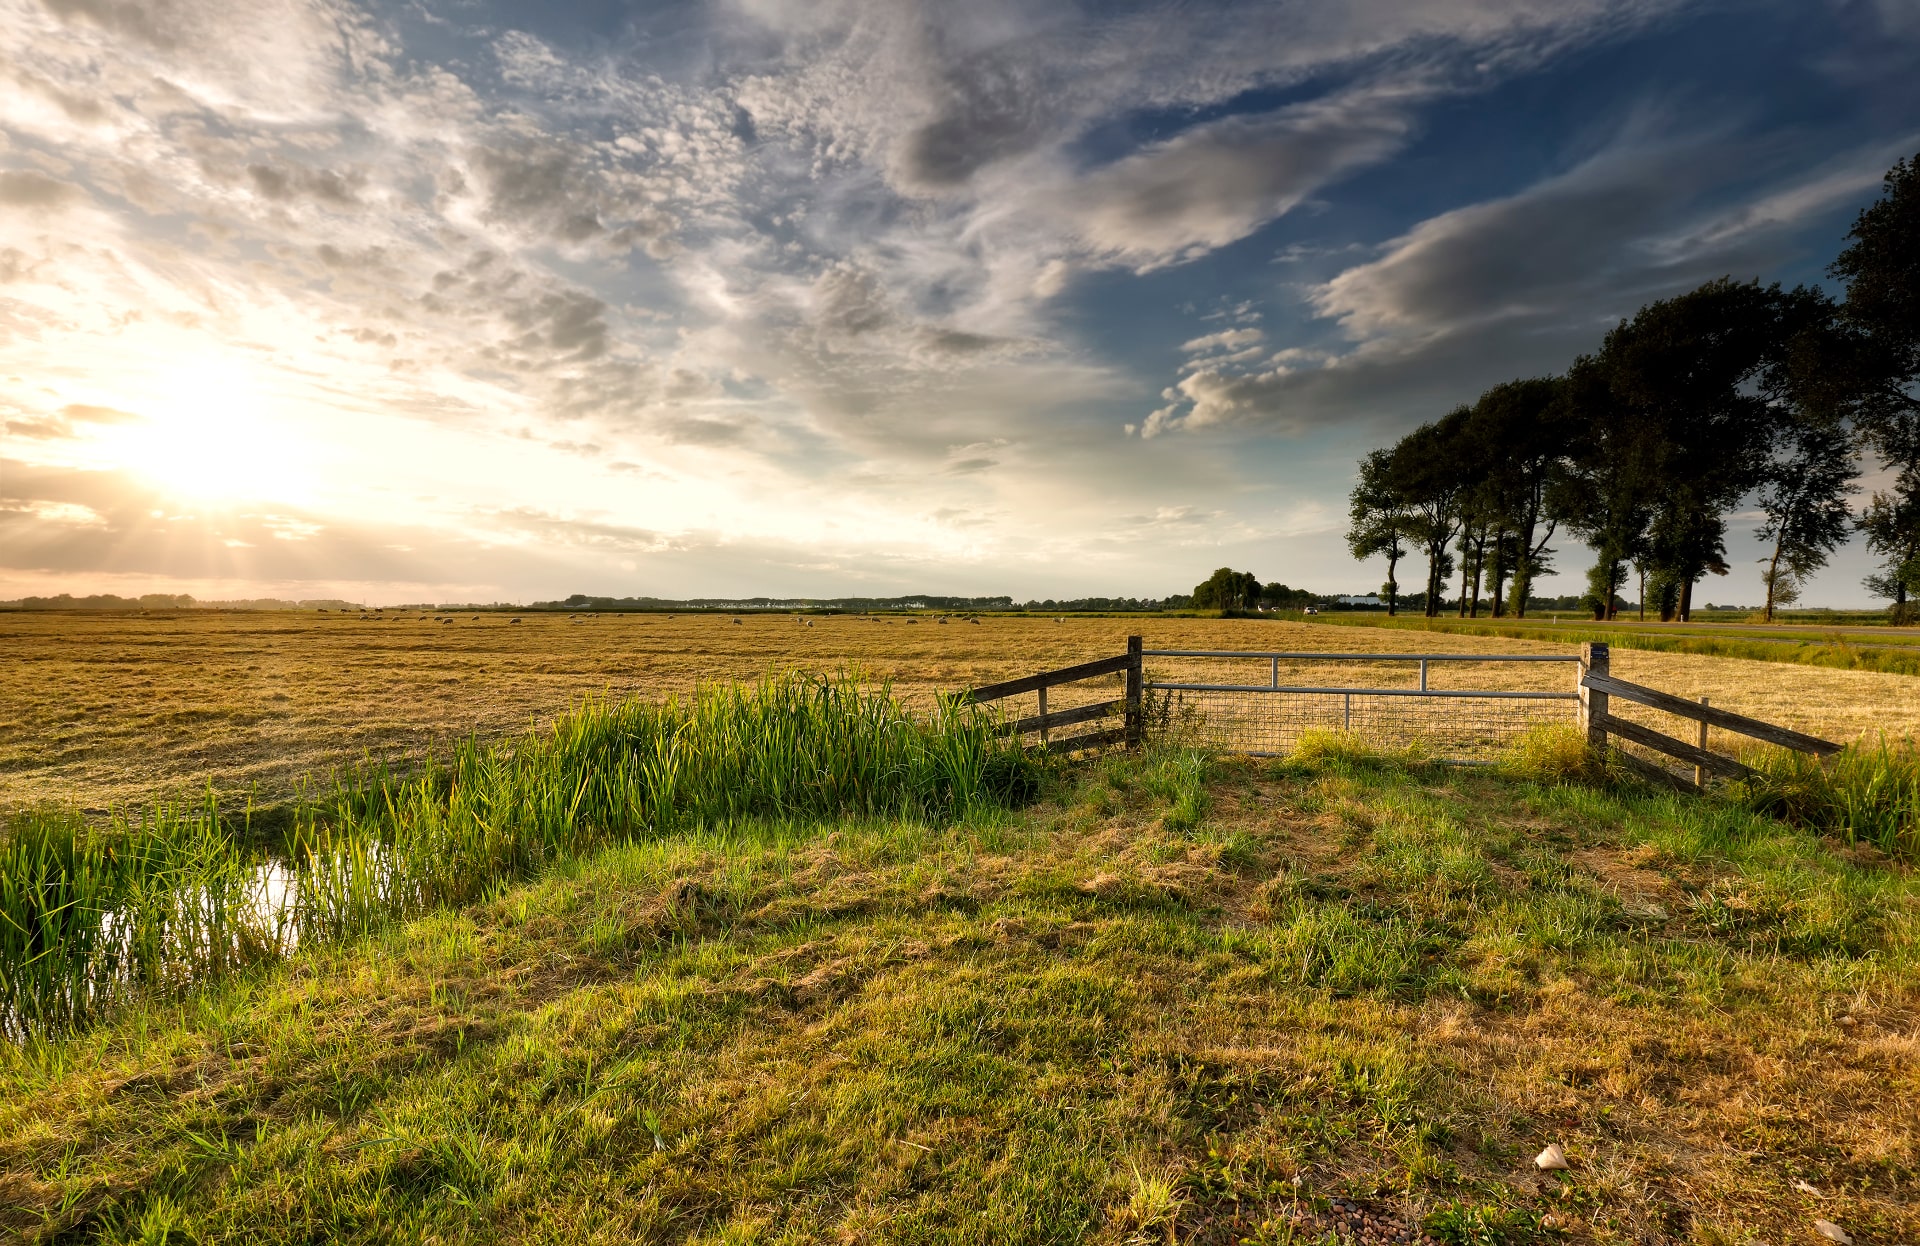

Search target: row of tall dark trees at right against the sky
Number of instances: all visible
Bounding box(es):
[1348,156,1920,622]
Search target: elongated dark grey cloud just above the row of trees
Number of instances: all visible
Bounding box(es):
[1139,134,1887,438]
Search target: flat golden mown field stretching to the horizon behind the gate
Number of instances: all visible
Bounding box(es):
[11,611,1920,810]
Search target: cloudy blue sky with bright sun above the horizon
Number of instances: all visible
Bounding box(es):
[0,0,1920,607]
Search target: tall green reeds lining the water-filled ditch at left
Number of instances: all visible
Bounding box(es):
[0,672,1039,1037]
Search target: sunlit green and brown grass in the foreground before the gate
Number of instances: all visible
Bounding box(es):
[0,745,1920,1244]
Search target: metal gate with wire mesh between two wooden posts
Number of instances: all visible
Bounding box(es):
[1144,649,1580,760]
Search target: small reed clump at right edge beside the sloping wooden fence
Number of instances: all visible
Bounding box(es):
[1736,735,1920,860]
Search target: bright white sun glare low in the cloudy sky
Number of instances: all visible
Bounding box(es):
[111,361,313,503]
